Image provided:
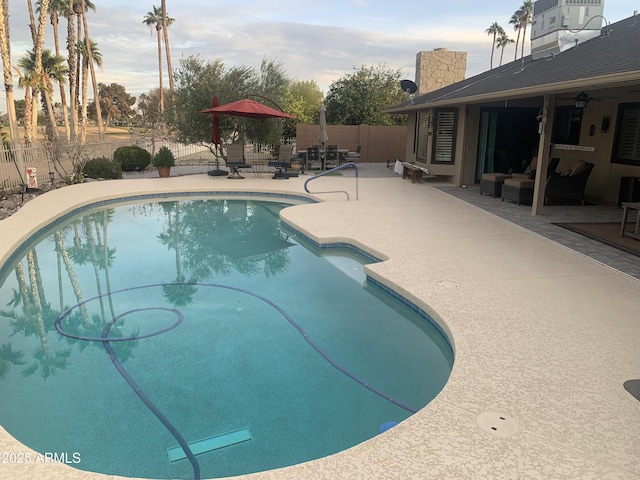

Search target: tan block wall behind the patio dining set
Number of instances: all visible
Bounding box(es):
[296,123,407,163]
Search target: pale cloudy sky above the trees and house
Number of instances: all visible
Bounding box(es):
[0,0,640,112]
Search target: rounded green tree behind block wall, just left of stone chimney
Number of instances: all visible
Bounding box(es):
[325,65,406,125]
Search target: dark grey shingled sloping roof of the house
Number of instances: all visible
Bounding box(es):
[385,15,640,113]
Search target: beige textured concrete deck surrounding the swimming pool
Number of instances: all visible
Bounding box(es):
[0,166,640,480]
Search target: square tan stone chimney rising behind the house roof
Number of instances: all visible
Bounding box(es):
[416,48,467,95]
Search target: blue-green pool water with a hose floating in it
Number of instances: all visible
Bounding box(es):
[0,198,453,478]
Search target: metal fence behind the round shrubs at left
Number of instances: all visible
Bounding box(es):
[0,139,214,192]
